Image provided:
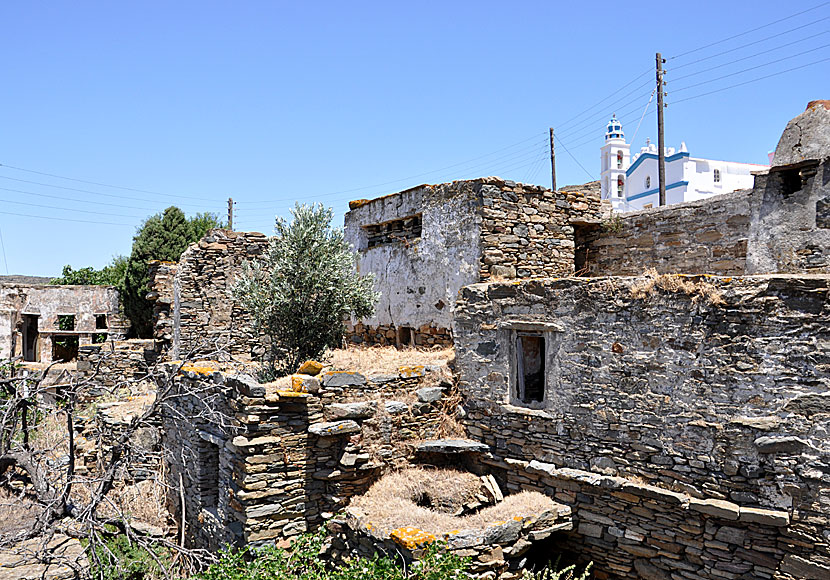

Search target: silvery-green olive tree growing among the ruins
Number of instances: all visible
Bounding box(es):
[234,204,378,374]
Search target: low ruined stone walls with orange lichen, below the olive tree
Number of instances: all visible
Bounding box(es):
[164,366,458,548]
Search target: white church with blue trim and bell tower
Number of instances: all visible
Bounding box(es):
[600,116,769,212]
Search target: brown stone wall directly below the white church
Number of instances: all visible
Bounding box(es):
[576,190,752,276]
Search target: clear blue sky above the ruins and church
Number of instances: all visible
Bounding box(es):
[0,0,830,275]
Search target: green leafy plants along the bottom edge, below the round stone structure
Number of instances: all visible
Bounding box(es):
[197,532,469,580]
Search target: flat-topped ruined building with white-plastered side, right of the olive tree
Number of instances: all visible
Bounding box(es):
[345,177,600,346]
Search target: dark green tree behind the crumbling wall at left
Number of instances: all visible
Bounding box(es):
[119,206,222,338]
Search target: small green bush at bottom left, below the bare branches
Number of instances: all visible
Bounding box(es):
[89,534,172,580]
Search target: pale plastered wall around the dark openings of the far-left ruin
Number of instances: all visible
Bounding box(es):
[0,284,118,362]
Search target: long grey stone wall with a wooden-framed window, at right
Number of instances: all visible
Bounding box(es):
[454,275,830,578]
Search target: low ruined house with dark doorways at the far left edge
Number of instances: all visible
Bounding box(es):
[0,284,125,363]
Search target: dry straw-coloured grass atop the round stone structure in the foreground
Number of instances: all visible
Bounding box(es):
[351,467,554,536]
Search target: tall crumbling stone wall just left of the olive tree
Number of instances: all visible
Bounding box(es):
[171,230,268,360]
